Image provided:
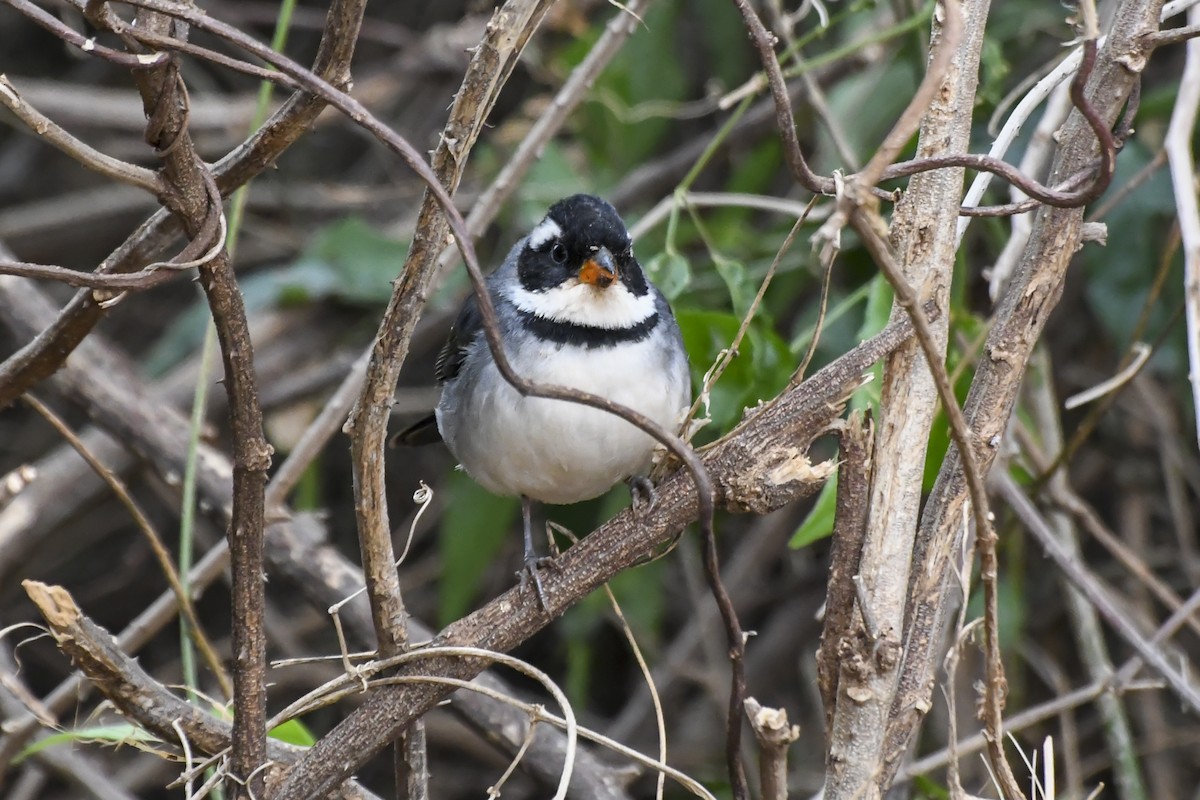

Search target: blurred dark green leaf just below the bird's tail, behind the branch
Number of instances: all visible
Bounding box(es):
[438,470,520,625]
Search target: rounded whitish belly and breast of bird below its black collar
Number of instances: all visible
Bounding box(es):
[438,337,691,504]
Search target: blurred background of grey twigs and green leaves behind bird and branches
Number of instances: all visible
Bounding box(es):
[0,0,1200,798]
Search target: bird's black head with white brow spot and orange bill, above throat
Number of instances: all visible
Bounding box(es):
[517,194,649,297]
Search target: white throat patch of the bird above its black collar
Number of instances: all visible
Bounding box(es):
[505,278,656,330]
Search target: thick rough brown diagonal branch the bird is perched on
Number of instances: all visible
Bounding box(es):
[280,309,926,798]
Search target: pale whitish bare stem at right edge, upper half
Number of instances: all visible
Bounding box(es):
[1163,7,1200,453]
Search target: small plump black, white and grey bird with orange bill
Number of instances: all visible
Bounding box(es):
[396,194,691,609]
